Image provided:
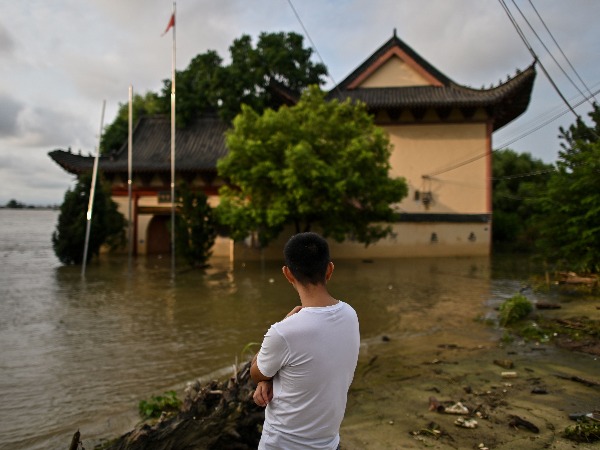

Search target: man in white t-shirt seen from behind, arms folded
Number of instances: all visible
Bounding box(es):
[250,233,360,450]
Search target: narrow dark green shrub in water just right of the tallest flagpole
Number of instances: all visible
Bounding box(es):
[175,184,217,267]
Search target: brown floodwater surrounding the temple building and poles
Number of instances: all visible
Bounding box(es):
[0,210,552,450]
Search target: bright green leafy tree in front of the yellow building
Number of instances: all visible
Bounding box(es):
[217,86,407,245]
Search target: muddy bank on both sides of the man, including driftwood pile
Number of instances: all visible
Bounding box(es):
[90,284,600,450]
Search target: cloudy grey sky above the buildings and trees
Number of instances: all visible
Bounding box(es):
[0,0,600,205]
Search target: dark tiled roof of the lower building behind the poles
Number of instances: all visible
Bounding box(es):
[49,116,227,174]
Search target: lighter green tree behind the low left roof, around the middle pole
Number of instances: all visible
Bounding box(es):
[100,92,163,155]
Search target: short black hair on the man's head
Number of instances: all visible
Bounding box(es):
[283,232,330,285]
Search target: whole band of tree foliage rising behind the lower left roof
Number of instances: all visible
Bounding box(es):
[100,32,327,154]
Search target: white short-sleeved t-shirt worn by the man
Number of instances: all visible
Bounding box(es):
[257,301,360,450]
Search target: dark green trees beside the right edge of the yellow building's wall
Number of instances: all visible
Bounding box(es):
[492,149,554,250]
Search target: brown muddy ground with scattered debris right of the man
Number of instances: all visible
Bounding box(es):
[340,305,600,450]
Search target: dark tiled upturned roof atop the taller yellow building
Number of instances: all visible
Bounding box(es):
[328,33,536,130]
